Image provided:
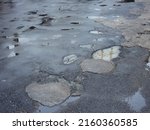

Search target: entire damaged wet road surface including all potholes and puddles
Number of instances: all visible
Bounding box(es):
[0,0,150,113]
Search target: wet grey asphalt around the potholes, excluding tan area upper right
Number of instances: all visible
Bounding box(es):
[0,0,150,112]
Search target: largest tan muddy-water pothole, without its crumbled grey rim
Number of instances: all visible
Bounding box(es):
[26,81,70,106]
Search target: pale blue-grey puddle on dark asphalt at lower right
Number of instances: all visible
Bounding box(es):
[125,89,146,112]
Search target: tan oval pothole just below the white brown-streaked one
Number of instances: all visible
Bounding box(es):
[81,59,115,74]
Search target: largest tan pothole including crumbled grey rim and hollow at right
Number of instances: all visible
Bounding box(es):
[26,75,83,107]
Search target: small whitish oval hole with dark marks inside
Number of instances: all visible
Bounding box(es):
[63,54,78,65]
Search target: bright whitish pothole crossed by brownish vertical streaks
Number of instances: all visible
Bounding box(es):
[92,46,121,61]
